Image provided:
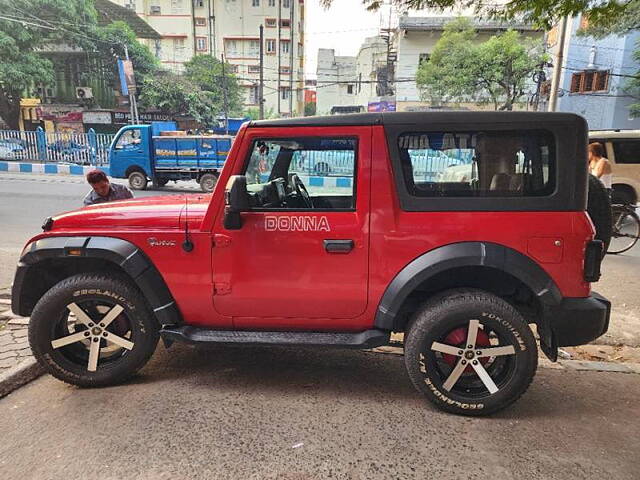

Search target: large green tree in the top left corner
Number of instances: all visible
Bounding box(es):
[0,0,96,129]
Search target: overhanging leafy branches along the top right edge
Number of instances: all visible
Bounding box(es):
[321,0,640,30]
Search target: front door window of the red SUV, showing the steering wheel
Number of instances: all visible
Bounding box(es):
[245,137,357,210]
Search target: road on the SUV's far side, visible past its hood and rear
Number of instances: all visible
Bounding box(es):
[0,173,640,347]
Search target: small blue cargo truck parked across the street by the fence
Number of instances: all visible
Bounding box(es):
[109,122,233,193]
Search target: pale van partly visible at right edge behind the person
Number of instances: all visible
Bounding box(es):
[589,130,640,204]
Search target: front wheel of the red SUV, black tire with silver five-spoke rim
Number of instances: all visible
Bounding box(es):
[29,274,159,387]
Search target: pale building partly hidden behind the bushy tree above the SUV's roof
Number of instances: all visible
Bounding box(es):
[395,15,544,111]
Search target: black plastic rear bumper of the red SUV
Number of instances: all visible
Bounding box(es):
[547,292,611,347]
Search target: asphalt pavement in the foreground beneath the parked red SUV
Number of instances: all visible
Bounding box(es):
[0,345,640,480]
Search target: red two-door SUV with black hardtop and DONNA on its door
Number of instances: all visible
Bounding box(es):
[12,112,610,415]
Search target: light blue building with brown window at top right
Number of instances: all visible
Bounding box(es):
[547,17,640,130]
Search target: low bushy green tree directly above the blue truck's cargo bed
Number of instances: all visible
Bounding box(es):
[139,72,219,125]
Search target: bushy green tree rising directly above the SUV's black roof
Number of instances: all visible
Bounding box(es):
[416,18,545,110]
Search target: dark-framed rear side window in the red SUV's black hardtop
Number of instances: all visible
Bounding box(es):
[398,130,556,197]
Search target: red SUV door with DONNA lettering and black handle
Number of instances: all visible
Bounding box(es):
[213,127,371,329]
